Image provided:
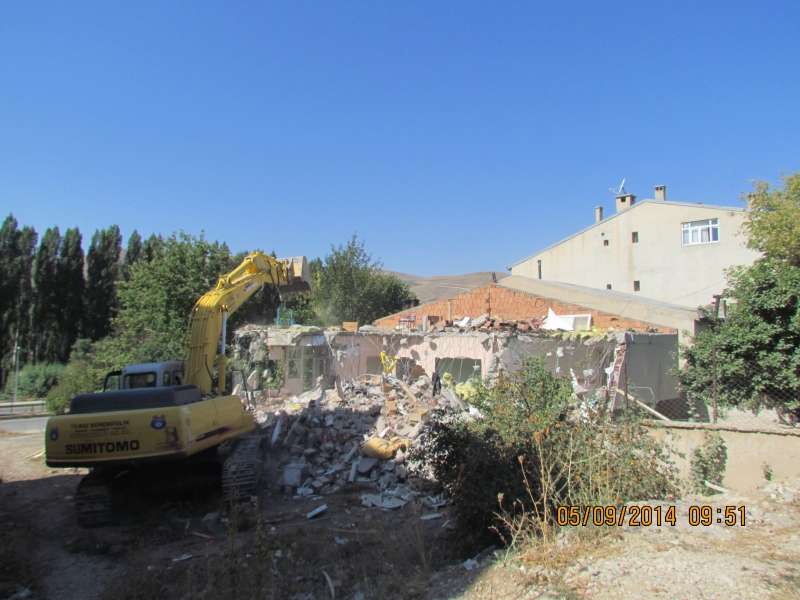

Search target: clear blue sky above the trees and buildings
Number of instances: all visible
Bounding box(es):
[0,0,800,276]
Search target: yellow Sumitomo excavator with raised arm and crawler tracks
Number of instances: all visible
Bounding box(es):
[45,252,311,527]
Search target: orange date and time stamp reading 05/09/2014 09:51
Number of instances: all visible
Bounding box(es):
[556,505,746,527]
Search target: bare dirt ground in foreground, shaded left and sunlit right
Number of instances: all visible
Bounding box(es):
[0,433,800,600]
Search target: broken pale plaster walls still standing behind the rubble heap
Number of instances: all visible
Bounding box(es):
[241,329,677,402]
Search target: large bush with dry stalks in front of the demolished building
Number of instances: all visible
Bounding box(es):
[414,358,677,544]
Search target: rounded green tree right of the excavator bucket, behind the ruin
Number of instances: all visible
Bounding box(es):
[314,234,415,325]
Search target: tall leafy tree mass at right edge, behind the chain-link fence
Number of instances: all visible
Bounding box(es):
[675,173,800,421]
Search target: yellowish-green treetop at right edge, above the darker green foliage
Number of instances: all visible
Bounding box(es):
[742,173,800,266]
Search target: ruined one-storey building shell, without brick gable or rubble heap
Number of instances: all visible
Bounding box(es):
[234,322,677,414]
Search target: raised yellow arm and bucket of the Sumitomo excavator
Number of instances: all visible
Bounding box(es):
[185,252,311,395]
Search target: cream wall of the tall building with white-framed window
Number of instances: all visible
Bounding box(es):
[511,200,759,307]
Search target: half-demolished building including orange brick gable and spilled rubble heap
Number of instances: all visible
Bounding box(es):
[227,277,699,502]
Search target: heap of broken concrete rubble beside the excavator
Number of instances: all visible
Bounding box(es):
[254,375,474,508]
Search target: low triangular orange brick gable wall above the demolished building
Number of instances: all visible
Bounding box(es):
[375,283,678,333]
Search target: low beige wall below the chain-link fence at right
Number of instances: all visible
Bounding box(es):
[650,426,800,492]
